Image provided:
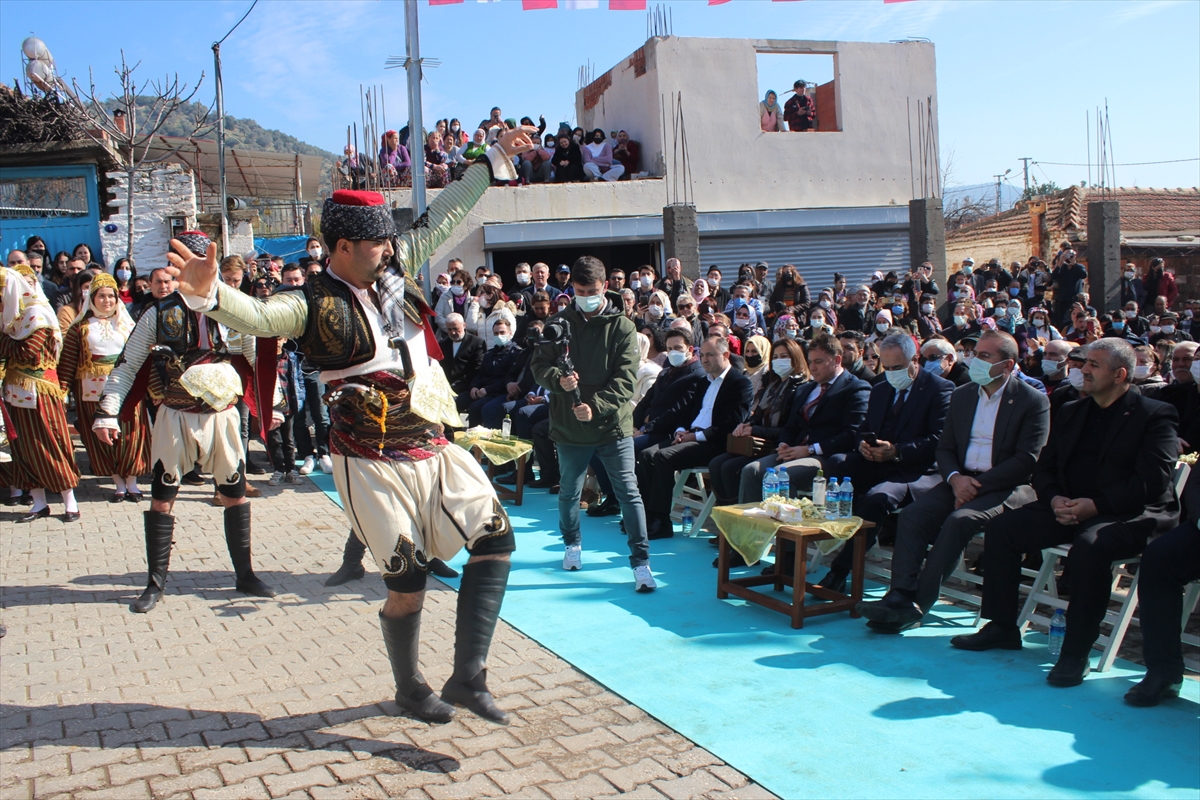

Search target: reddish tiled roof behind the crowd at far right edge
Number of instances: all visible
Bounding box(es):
[946,186,1200,242]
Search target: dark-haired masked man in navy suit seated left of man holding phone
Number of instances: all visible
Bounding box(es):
[738,333,871,503]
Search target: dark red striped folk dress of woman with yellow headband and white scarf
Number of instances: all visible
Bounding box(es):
[58,319,150,477]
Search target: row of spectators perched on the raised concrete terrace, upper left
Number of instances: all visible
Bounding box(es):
[336,108,641,188]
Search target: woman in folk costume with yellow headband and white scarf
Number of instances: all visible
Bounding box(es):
[59,272,150,503]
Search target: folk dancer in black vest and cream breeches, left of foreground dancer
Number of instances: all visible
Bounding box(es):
[92,231,275,614]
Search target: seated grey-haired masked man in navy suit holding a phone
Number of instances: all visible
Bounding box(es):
[821,332,954,591]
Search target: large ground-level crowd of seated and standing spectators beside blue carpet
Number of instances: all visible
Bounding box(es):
[432,250,1200,704]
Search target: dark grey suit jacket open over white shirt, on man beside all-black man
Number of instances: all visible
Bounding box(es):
[937,377,1050,500]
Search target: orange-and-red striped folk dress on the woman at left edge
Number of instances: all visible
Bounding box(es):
[0,327,79,492]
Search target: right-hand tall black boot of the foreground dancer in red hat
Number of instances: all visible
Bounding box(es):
[442,560,510,724]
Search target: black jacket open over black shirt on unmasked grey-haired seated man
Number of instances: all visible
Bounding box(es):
[1033,391,1180,533]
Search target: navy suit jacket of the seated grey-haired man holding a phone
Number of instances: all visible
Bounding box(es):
[863,369,954,488]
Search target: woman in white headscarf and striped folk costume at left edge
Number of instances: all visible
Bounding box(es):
[0,269,79,522]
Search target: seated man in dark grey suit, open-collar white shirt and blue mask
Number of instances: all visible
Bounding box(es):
[858,331,1050,633]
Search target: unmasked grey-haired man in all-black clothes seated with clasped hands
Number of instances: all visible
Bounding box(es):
[950,338,1180,686]
